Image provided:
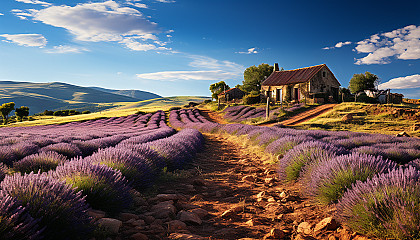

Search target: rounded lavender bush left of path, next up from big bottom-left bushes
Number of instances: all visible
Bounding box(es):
[51,159,132,214]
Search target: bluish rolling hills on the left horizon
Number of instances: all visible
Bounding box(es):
[0,81,159,114]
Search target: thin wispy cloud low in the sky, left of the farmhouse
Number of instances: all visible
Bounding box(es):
[137,55,245,81]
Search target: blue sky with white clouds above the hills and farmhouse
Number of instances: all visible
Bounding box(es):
[0,0,420,98]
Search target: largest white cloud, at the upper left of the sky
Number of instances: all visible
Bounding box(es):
[12,0,169,51]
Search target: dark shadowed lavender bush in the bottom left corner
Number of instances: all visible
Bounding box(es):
[0,191,42,240]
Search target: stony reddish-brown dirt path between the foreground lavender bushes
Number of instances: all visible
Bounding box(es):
[144,135,332,240]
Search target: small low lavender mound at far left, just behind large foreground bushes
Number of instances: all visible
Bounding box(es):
[13,152,67,173]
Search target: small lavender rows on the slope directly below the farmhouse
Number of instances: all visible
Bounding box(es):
[223,104,303,122]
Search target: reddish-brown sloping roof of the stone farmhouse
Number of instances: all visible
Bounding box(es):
[262,64,328,86]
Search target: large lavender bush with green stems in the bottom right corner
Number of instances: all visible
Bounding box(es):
[337,167,420,239]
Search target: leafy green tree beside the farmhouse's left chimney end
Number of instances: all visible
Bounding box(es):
[242,63,274,92]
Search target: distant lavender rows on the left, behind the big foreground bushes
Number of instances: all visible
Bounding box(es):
[0,111,173,166]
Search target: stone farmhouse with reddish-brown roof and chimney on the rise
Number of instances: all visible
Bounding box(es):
[261,63,341,103]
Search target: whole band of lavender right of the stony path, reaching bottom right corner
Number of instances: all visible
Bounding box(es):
[169,109,420,239]
